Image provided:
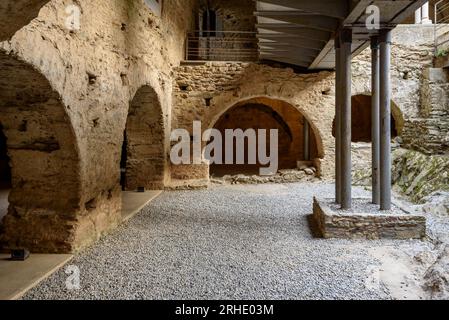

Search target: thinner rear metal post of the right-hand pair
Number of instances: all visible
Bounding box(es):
[371,36,380,204]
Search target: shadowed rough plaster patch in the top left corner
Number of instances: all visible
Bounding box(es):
[0,0,49,41]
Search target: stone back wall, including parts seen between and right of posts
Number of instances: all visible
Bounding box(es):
[172,26,433,184]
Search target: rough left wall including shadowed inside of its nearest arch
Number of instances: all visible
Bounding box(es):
[0,0,195,252]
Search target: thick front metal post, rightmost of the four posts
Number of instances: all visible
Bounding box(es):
[379,29,391,210]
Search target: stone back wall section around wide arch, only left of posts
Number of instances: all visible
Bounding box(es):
[172,62,334,178]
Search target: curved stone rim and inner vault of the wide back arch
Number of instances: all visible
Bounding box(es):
[207,96,324,176]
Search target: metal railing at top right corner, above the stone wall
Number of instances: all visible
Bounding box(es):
[434,0,449,55]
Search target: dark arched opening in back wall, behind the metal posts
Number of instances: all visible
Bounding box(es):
[332,94,404,142]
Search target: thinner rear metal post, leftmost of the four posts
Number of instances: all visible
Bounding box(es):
[335,38,342,204]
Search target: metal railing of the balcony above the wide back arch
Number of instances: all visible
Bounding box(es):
[186,31,259,61]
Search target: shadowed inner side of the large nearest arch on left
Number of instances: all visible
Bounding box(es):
[0,52,81,252]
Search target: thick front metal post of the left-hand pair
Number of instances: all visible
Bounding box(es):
[340,29,352,210]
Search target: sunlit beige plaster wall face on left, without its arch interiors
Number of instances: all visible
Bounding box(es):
[0,0,193,252]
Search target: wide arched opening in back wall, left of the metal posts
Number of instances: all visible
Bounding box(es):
[210,98,320,177]
